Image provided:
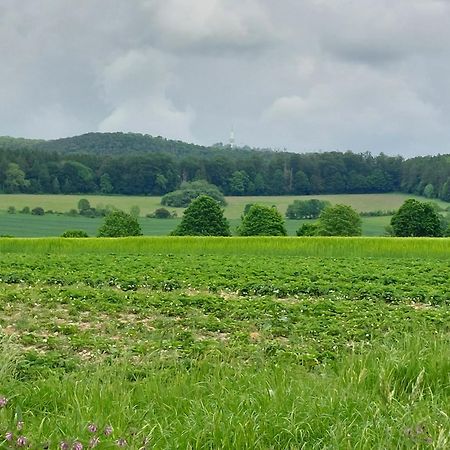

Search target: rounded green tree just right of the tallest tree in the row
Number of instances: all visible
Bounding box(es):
[238,205,287,236]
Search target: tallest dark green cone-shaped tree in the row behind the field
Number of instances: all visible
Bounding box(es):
[171,195,230,236]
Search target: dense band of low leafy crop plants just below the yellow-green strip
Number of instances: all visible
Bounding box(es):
[0,253,450,304]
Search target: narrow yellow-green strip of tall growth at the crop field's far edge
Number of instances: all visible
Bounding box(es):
[0,236,450,259]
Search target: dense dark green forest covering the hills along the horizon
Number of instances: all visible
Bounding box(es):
[0,133,450,201]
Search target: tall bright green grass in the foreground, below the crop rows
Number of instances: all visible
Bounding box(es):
[0,335,450,450]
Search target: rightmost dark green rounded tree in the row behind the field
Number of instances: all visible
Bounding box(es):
[391,198,443,237]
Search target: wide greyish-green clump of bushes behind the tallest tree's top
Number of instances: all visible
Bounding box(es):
[161,180,226,208]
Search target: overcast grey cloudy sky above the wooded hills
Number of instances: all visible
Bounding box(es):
[0,0,450,157]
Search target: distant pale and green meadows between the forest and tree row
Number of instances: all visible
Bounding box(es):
[0,194,448,237]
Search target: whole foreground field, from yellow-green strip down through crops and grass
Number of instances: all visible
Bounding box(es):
[0,237,450,449]
